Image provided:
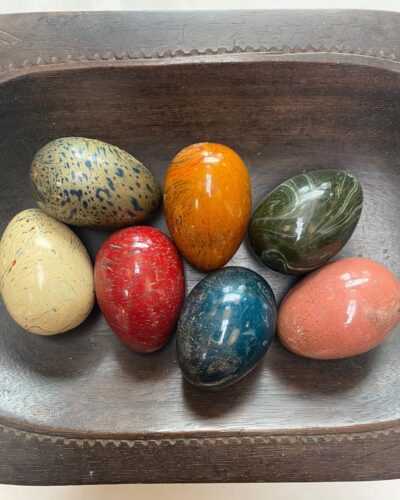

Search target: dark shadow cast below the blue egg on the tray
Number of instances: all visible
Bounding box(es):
[182,360,265,418]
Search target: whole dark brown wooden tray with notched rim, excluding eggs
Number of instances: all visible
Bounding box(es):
[0,7,400,484]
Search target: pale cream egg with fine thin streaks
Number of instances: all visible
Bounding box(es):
[0,209,94,335]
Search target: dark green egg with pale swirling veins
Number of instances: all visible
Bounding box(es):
[249,170,363,274]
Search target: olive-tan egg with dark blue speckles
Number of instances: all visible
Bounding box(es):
[30,137,161,228]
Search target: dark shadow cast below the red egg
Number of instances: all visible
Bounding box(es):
[112,336,176,381]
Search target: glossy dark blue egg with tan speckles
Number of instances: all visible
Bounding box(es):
[177,267,277,389]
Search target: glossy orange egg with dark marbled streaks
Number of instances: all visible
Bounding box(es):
[164,142,251,271]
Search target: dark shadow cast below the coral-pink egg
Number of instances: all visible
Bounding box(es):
[265,339,377,396]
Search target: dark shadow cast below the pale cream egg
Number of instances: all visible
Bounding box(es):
[2,306,104,379]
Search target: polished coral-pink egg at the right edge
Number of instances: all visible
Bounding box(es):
[278,257,400,359]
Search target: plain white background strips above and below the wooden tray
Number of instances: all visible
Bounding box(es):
[0,0,400,500]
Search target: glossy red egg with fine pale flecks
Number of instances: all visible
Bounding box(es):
[94,226,185,352]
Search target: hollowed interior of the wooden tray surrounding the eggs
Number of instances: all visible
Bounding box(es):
[0,59,400,434]
